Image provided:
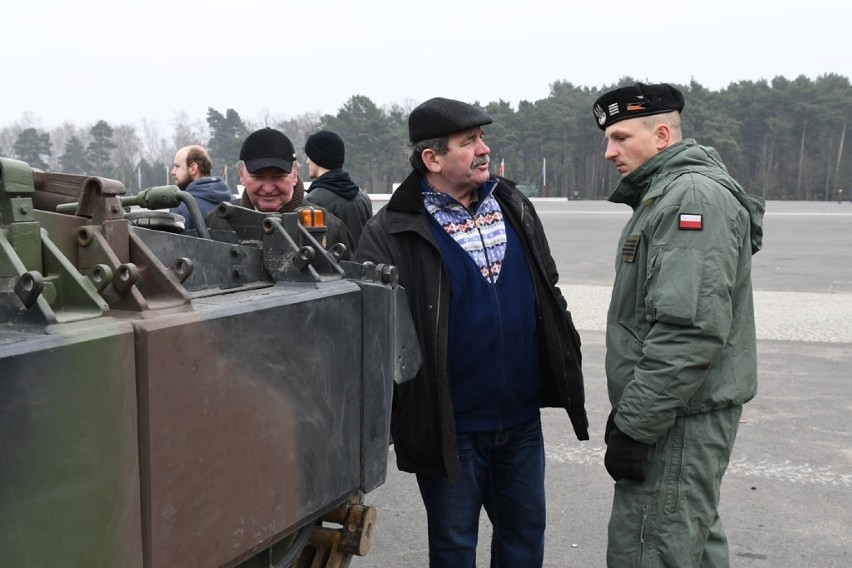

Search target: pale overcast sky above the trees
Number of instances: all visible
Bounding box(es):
[0,0,852,128]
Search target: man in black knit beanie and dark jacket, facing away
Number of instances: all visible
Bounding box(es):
[305,130,373,251]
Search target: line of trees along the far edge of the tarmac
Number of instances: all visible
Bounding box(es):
[0,74,852,200]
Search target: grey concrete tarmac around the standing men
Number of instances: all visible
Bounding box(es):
[352,200,852,568]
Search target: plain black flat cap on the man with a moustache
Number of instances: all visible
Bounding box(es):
[408,97,494,142]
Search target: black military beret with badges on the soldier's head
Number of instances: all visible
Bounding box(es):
[593,83,683,130]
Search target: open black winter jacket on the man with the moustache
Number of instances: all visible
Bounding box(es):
[355,172,589,481]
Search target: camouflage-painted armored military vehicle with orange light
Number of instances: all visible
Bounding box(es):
[0,159,420,568]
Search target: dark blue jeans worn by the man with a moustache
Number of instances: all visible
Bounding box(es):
[417,418,546,568]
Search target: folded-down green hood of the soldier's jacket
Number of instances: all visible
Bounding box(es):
[609,138,766,254]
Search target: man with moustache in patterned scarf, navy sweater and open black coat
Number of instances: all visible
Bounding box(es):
[355,98,588,568]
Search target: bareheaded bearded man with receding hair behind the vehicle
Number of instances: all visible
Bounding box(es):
[169,146,234,230]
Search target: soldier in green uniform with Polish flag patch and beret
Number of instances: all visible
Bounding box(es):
[593,83,764,568]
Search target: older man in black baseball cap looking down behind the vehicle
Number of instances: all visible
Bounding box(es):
[206,127,353,254]
